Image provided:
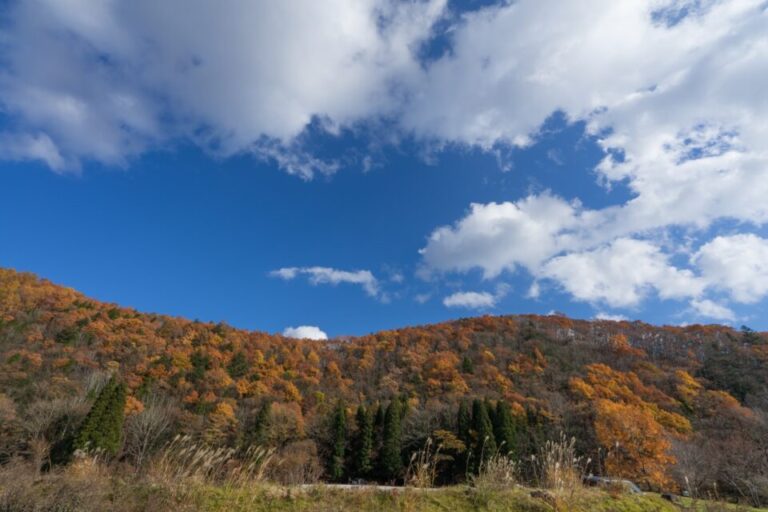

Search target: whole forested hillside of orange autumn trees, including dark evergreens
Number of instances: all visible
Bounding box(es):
[0,270,768,504]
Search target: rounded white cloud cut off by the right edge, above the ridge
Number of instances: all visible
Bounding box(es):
[693,234,768,303]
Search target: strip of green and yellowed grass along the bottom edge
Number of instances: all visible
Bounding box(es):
[0,472,758,512]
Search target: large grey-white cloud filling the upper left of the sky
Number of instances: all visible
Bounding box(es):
[0,0,445,177]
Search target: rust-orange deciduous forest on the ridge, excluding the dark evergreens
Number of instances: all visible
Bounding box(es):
[0,269,768,504]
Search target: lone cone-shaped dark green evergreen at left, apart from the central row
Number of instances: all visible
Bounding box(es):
[74,376,126,455]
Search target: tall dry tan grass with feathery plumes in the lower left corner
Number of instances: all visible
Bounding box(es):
[0,437,273,512]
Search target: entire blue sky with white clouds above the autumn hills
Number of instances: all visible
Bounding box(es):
[0,0,768,337]
